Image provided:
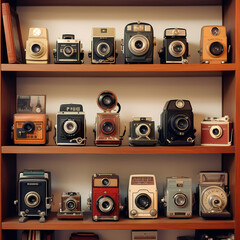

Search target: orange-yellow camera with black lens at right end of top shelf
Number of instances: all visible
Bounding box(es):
[199,26,228,64]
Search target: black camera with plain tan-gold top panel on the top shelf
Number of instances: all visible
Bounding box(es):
[88,28,117,63]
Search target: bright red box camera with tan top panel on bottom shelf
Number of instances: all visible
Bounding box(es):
[91,174,121,221]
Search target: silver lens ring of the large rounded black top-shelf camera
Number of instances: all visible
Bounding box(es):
[128,34,150,56]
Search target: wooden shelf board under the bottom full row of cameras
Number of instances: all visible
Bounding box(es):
[2,213,235,230]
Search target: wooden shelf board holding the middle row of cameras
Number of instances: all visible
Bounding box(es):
[2,146,235,154]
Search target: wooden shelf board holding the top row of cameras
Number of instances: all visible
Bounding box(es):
[1,63,236,77]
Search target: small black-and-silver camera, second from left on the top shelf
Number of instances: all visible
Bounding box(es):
[53,34,84,64]
